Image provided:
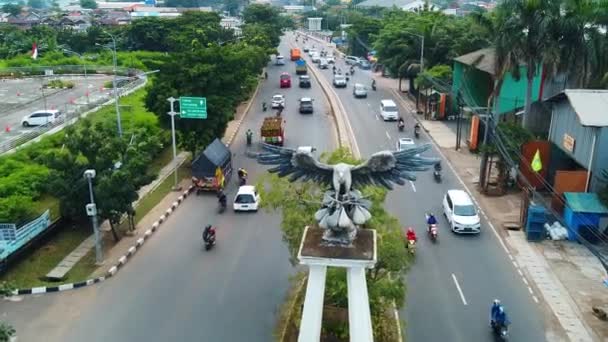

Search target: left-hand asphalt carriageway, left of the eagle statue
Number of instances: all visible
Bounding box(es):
[0,37,335,342]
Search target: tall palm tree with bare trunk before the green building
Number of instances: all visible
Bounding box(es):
[495,0,560,128]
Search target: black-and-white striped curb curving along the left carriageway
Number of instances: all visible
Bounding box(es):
[13,185,194,296]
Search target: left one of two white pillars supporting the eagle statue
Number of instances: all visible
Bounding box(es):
[298,265,328,342]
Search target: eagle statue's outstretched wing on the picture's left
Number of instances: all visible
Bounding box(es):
[257,144,333,185]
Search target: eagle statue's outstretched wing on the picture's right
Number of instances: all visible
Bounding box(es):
[351,144,439,189]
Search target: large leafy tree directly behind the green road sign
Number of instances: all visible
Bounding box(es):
[146,43,268,155]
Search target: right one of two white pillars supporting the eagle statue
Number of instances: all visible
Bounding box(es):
[346,266,374,342]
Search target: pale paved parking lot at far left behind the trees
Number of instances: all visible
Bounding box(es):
[0,75,112,145]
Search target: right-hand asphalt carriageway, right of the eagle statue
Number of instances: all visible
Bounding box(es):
[290,32,546,342]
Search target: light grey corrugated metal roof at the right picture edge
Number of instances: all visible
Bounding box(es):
[564,89,608,127]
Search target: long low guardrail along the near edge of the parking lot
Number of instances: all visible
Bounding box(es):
[0,79,146,154]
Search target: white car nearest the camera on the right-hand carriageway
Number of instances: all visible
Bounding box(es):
[443,190,481,234]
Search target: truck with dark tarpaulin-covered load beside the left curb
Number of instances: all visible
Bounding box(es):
[192,139,232,194]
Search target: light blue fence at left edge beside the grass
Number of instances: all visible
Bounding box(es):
[0,210,51,261]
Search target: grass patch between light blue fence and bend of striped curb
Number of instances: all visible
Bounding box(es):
[0,227,94,288]
